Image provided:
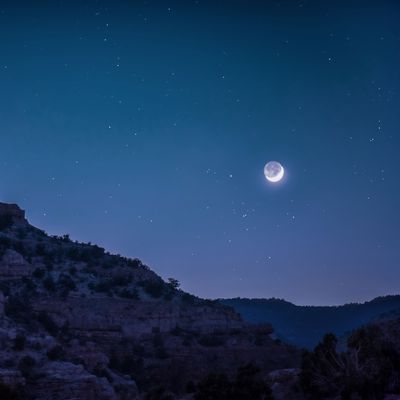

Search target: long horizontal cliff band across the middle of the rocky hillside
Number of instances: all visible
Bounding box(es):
[32,295,244,338]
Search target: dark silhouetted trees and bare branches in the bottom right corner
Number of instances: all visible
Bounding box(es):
[300,325,400,400]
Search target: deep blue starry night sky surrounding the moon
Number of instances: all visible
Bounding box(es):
[0,0,400,304]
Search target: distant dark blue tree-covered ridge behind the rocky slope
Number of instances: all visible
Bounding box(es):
[219,295,400,349]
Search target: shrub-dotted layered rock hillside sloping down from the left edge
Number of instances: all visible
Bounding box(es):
[0,205,299,400]
